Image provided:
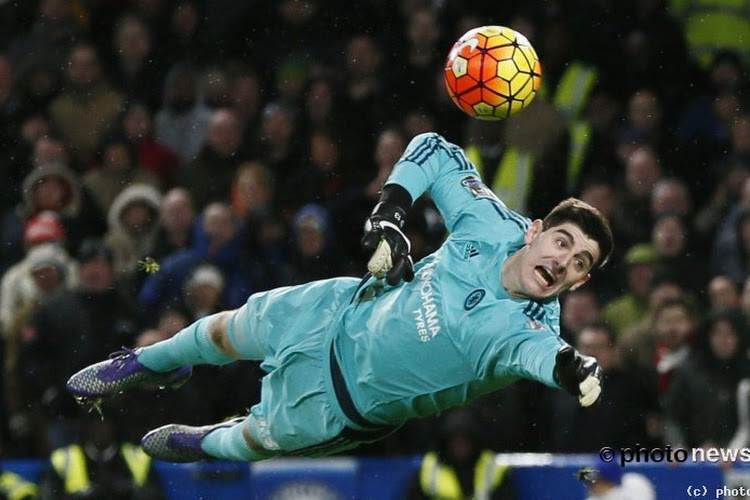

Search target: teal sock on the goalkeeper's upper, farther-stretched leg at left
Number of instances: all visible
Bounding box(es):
[138,315,235,372]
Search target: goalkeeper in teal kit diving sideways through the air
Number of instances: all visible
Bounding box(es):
[67,133,612,462]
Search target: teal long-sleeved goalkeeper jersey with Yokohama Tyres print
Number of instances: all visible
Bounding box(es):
[334,133,564,425]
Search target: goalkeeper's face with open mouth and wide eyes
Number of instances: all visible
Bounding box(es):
[517,220,599,299]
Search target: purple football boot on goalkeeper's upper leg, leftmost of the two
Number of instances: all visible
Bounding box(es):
[66,347,193,403]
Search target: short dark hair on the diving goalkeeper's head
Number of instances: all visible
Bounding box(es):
[542,198,614,268]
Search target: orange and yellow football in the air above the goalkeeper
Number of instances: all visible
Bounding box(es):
[445,26,542,120]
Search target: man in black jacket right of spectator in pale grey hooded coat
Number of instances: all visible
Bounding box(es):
[178,108,245,210]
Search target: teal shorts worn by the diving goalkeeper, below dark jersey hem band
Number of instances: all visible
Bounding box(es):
[229,278,393,456]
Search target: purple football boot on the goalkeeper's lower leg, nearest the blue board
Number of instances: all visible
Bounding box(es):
[141,417,245,462]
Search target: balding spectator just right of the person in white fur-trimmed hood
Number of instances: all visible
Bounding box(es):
[150,188,197,261]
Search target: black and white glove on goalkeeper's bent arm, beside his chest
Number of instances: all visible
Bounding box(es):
[362,202,414,286]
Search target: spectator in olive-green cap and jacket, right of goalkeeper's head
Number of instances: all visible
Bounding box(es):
[602,243,657,334]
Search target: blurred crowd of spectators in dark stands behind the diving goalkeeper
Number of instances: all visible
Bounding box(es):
[0,0,750,472]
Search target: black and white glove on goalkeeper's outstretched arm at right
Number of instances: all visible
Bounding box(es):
[554,345,602,406]
